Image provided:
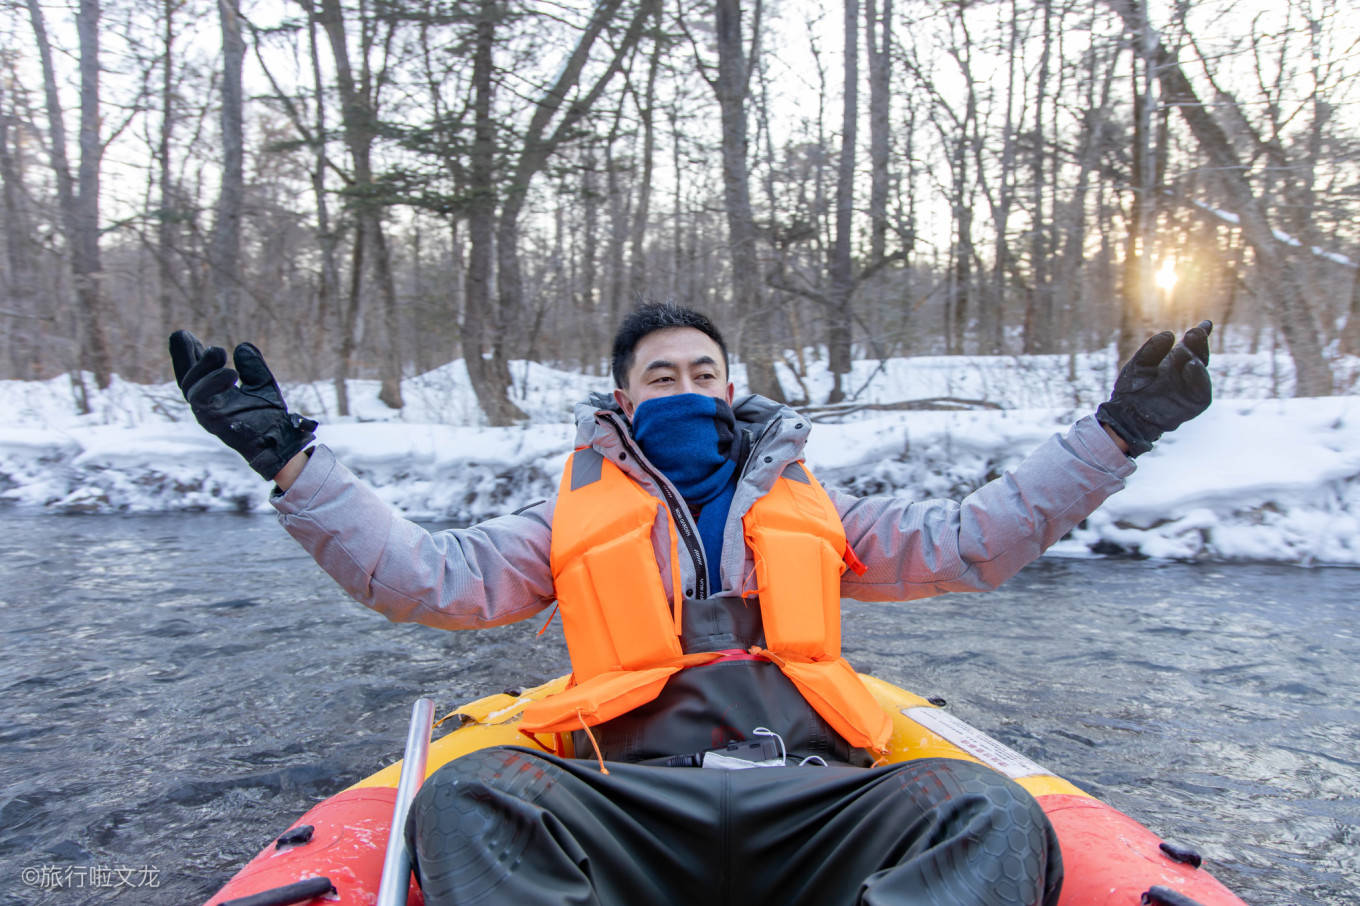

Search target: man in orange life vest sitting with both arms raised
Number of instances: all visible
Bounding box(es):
[171,305,1212,906]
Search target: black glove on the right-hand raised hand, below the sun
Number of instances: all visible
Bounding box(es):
[1096,321,1213,456]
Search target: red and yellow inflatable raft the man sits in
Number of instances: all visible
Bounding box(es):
[198,676,1243,906]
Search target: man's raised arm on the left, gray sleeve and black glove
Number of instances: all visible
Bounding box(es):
[170,331,554,628]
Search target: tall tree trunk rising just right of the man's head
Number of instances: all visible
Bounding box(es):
[713,0,785,403]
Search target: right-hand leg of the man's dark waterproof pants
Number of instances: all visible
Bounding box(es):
[719,758,1062,906]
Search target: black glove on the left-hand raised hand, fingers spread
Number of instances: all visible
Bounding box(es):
[170,331,317,480]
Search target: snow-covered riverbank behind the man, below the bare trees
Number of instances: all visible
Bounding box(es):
[0,346,1360,565]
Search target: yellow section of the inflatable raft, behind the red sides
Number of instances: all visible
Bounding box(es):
[342,673,1091,799]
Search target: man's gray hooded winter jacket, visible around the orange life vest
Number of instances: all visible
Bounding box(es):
[272,396,1134,628]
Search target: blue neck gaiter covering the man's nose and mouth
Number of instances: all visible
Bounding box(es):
[632,393,738,594]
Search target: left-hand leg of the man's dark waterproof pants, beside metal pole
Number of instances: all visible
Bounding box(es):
[407,747,717,906]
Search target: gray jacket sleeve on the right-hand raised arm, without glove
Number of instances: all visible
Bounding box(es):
[828,416,1134,601]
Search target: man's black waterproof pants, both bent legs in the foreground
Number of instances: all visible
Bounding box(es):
[407,748,1062,906]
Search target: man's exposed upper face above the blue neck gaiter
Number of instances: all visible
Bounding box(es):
[613,328,733,419]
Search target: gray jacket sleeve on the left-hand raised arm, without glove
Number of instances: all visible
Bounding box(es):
[271,446,555,628]
